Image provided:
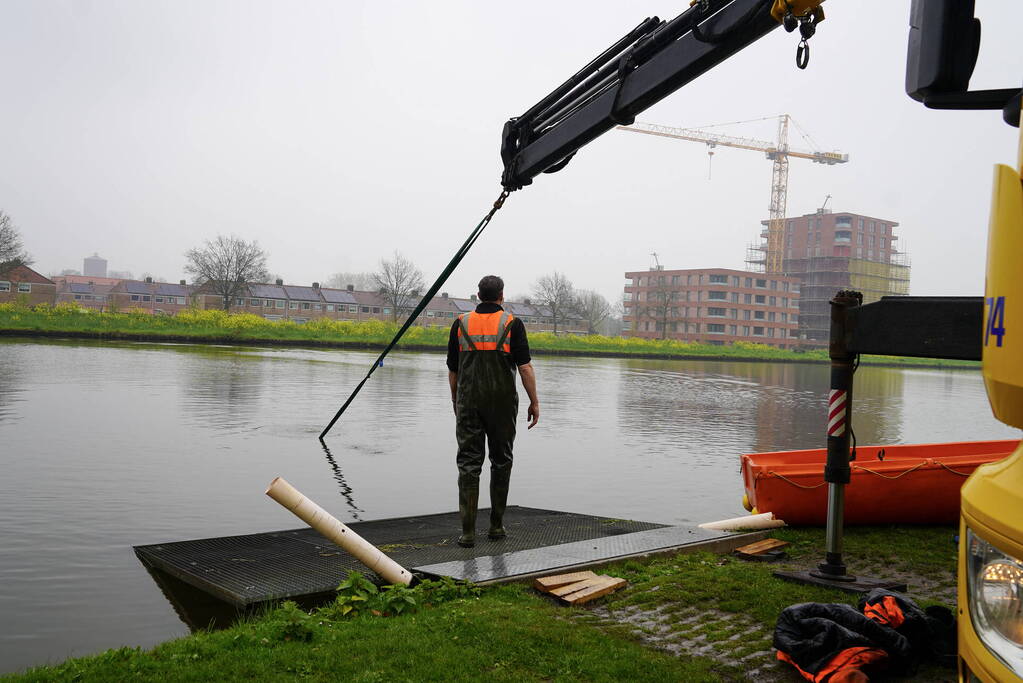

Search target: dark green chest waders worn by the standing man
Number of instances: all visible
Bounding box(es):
[455,319,519,548]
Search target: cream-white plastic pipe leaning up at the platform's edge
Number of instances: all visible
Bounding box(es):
[266,476,412,586]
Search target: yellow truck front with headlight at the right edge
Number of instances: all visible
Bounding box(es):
[959,114,1023,681]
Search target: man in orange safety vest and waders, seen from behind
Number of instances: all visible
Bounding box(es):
[447,275,540,548]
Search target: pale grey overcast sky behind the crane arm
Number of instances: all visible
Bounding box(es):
[0,0,1023,299]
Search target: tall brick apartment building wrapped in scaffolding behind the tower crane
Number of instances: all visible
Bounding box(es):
[746,209,909,346]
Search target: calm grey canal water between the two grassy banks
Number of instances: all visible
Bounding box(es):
[0,339,1019,673]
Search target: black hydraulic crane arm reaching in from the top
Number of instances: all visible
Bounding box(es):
[501,0,824,190]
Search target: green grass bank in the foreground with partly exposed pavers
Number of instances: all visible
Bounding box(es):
[8,527,955,683]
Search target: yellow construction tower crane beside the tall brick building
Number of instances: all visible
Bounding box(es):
[617,113,849,273]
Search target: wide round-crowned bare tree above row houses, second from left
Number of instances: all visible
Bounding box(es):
[185,235,268,311]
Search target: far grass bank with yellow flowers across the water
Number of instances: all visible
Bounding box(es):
[0,304,979,368]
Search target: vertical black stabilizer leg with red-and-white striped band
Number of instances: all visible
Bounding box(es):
[810,291,863,581]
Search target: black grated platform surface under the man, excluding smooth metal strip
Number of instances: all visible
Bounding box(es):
[135,506,664,607]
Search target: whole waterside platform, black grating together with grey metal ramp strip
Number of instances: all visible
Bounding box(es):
[135,506,749,608]
